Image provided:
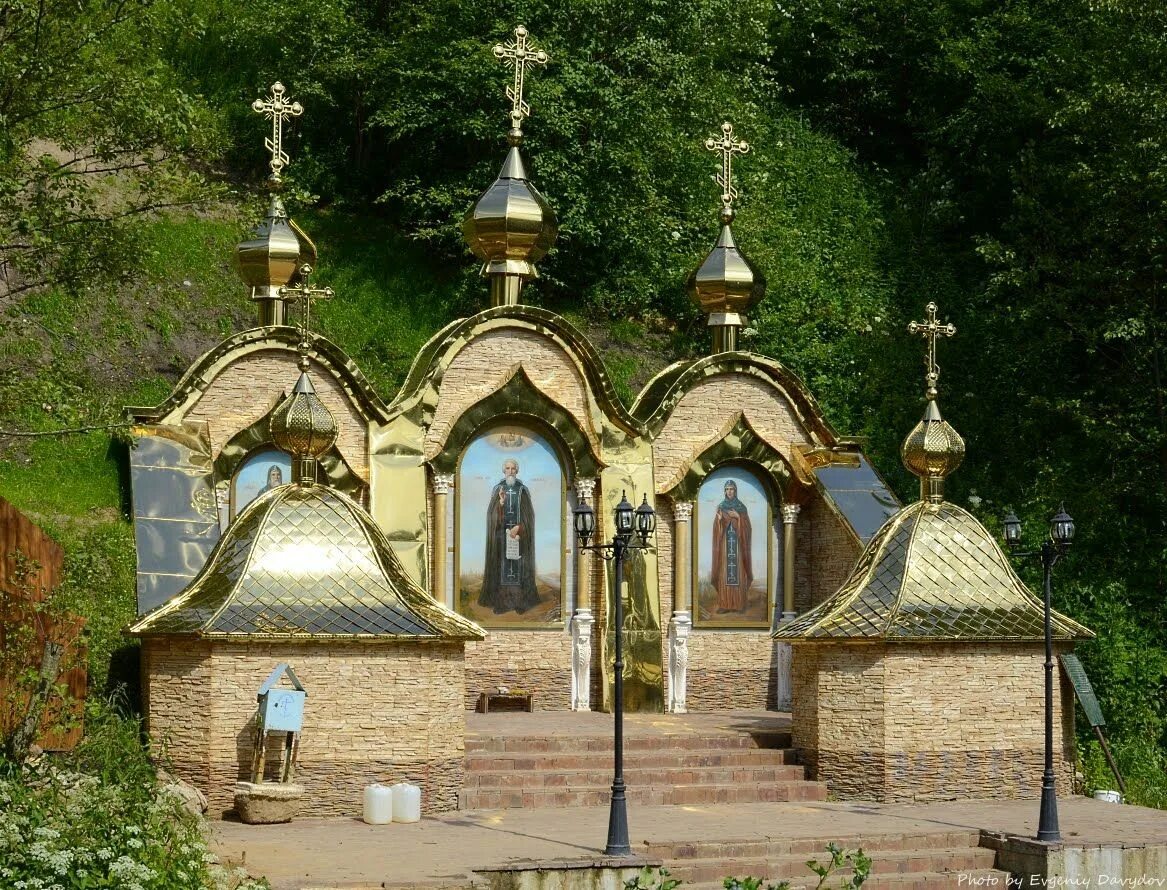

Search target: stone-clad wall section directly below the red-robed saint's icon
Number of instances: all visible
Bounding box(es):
[685,629,777,710]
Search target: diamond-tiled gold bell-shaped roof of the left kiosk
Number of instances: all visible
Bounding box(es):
[130,484,485,639]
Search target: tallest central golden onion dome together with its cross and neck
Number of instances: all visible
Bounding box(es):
[462,26,559,306]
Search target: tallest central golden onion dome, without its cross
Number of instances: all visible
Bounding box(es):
[462,146,559,279]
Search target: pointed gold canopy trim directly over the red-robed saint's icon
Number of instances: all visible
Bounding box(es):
[657,411,813,502]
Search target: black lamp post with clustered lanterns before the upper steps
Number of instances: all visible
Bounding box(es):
[574,492,656,856]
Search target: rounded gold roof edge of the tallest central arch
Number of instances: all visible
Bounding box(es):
[389,306,643,436]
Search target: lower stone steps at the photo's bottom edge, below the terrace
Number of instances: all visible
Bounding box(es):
[637,826,1009,890]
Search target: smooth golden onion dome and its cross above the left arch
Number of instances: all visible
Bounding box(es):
[235,80,316,325]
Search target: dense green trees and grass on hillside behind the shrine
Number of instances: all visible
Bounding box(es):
[0,0,1167,806]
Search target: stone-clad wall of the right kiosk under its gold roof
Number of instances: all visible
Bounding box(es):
[794,643,1074,801]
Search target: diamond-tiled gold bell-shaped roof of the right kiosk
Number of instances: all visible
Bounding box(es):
[773,502,1093,643]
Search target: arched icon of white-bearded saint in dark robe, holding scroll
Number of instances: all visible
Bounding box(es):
[454,426,566,628]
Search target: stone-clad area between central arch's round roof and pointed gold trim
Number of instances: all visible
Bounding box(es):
[425,329,599,458]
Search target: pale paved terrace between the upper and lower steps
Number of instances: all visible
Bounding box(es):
[215,798,1167,890]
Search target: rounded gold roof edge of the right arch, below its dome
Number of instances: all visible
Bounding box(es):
[631,352,846,449]
